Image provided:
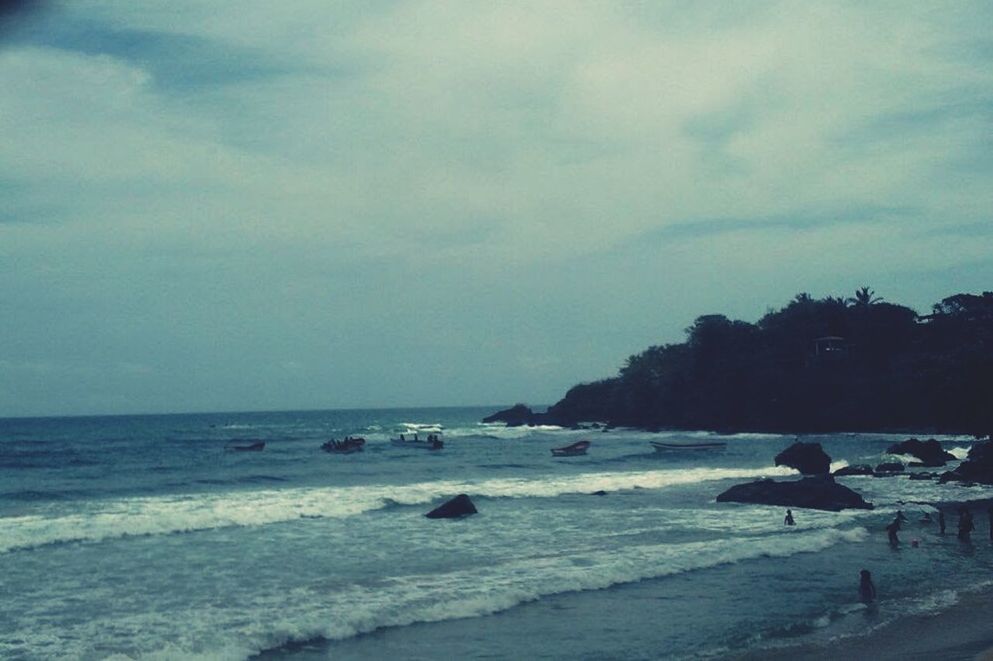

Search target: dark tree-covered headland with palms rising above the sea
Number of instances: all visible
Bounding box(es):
[548,287,993,435]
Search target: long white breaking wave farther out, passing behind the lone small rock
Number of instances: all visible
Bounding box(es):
[0,466,795,552]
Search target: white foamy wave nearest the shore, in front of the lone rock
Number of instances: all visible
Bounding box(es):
[0,528,868,661]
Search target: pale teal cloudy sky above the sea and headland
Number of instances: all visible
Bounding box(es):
[0,0,993,416]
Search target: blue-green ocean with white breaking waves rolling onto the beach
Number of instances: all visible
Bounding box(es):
[0,407,993,659]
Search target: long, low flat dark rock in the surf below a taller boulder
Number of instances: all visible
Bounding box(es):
[717,475,872,512]
